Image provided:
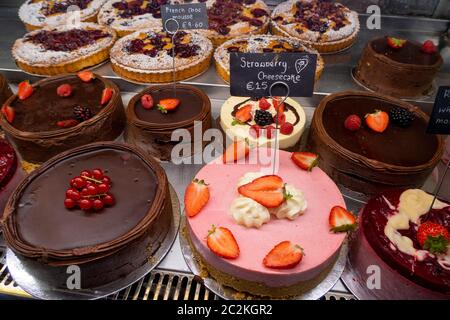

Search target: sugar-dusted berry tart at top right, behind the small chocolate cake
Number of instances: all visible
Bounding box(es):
[271,0,359,53]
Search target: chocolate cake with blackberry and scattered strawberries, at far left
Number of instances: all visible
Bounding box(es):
[0,75,126,163]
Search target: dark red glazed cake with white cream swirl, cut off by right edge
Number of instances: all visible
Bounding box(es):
[349,189,450,299]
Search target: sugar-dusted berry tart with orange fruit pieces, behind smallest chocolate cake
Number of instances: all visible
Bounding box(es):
[111,29,213,83]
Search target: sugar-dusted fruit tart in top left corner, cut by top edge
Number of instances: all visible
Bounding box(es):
[19,0,106,31]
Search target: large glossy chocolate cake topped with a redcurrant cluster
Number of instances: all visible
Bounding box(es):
[3,142,172,289]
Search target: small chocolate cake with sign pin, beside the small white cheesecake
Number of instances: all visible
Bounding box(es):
[125,84,212,160]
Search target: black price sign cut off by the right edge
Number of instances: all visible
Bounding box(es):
[427,87,450,134]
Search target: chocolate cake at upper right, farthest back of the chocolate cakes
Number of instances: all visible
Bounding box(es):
[355,37,443,98]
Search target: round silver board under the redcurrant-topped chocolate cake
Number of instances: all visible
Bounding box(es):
[6,185,180,300]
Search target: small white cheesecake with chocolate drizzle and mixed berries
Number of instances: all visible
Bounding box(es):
[220,97,306,149]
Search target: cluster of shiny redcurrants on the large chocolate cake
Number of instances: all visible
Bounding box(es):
[64,169,115,211]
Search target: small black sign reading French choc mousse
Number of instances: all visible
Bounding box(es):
[161,3,209,30]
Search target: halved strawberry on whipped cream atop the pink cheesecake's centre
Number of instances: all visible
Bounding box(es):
[238,175,284,208]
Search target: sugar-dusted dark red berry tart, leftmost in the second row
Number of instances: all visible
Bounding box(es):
[12,23,116,75]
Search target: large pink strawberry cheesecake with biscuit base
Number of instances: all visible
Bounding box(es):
[187,148,345,297]
